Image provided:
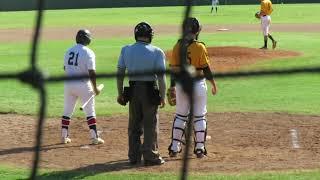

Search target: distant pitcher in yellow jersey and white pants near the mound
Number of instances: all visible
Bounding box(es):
[259,0,277,49]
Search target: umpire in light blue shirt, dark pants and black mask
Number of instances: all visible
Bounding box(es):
[117,22,166,165]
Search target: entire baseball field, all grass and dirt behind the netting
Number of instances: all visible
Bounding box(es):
[0,4,320,179]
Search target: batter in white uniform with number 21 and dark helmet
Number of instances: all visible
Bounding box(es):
[61,29,104,144]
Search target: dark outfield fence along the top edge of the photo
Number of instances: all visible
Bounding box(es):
[0,0,320,11]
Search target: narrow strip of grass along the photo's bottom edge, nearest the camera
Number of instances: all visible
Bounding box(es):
[0,166,320,180]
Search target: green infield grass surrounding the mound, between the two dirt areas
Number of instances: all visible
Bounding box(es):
[0,32,320,116]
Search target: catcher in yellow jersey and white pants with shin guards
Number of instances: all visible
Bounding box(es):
[168,18,217,158]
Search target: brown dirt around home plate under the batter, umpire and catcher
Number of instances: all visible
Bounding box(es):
[0,113,320,172]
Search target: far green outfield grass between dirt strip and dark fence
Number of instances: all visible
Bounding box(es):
[0,1,320,28]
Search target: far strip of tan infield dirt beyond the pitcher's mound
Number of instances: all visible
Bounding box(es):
[0,22,320,42]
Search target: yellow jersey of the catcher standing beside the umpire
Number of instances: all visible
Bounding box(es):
[169,40,210,70]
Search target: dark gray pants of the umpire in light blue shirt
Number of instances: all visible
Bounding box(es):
[128,82,160,161]
